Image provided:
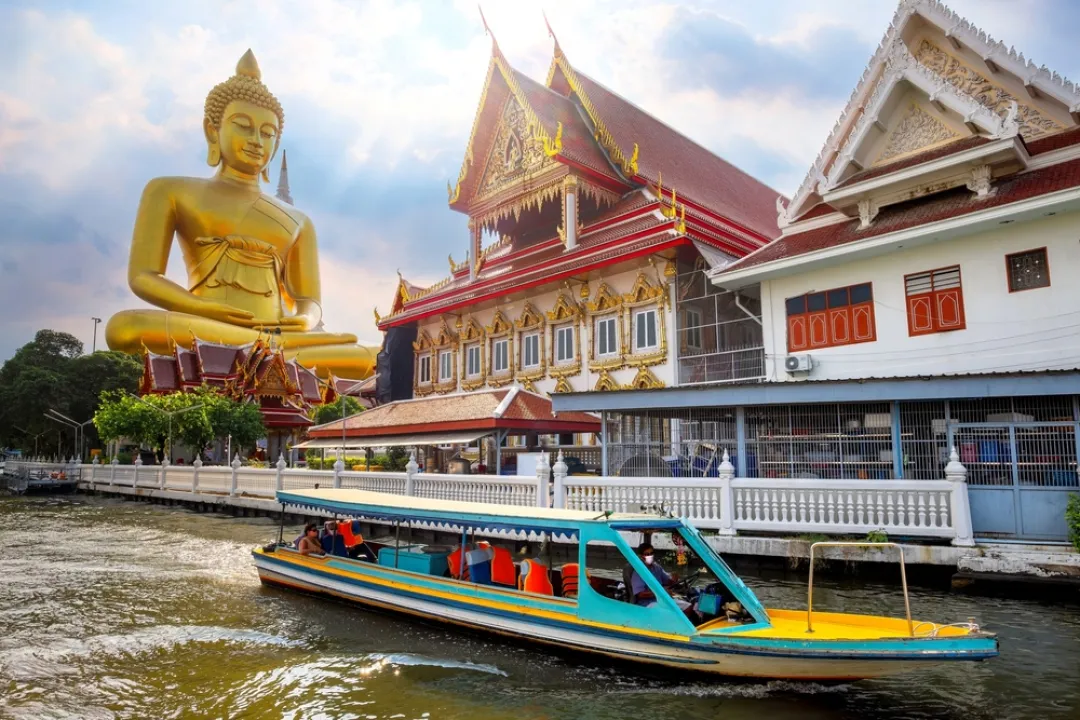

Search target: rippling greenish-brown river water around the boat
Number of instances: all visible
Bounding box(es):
[0,495,1080,720]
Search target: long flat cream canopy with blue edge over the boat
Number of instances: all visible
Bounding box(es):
[278,488,683,535]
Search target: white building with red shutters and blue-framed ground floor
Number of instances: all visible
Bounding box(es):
[555,0,1080,540]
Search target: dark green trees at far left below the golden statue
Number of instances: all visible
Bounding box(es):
[0,330,143,453]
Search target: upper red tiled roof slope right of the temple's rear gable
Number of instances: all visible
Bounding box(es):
[575,69,780,237]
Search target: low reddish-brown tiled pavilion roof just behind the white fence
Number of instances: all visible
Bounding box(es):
[311,389,600,437]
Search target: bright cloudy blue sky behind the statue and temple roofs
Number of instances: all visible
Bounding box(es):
[0,0,1080,362]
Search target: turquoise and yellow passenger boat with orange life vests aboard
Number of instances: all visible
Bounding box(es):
[254,489,998,681]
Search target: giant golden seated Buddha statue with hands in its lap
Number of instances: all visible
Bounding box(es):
[105,50,378,379]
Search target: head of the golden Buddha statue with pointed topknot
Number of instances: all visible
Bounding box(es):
[203,50,285,181]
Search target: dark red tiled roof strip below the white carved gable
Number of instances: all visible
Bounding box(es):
[719,160,1080,277]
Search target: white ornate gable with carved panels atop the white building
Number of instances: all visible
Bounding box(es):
[777,0,1080,228]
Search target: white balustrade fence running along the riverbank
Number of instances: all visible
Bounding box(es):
[59,450,973,545]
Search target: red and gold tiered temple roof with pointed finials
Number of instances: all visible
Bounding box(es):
[376,19,780,329]
